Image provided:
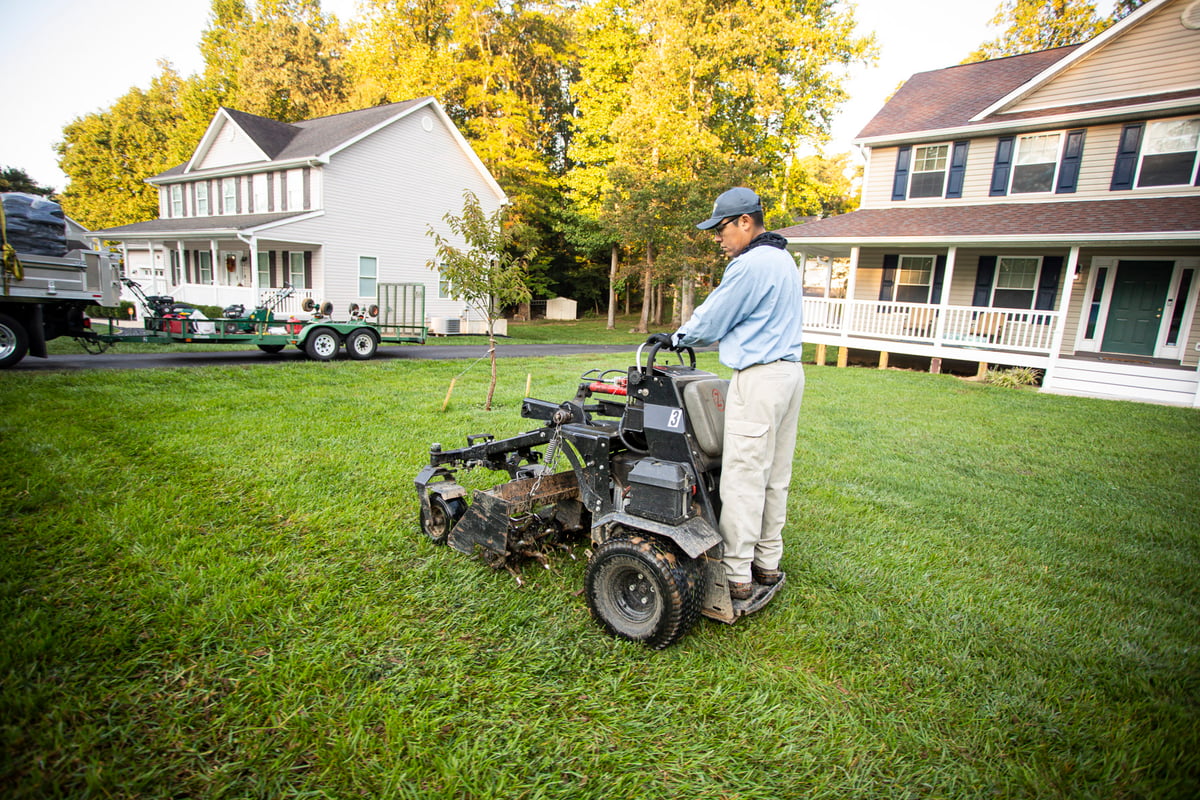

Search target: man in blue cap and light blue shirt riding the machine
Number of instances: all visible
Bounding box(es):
[671,187,804,600]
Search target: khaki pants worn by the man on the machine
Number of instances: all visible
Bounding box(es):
[720,361,804,583]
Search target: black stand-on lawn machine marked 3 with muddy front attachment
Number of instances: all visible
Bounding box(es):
[415,339,784,649]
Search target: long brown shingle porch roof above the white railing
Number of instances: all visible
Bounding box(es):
[778,197,1200,242]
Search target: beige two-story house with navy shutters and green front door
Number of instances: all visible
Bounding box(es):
[780,0,1200,405]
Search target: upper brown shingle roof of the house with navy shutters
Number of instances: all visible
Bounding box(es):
[858,44,1080,139]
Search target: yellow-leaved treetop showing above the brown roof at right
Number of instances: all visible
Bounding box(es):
[962,0,1108,64]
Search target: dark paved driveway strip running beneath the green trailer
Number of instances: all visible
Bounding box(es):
[4,344,676,372]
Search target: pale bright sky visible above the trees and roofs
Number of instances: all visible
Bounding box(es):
[0,0,1032,191]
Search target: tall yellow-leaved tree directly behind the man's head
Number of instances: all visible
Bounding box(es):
[571,0,872,329]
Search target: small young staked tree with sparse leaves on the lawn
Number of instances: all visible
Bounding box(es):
[427,190,536,411]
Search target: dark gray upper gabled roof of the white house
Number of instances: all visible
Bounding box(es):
[157,97,436,184]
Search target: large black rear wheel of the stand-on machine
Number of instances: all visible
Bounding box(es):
[584,536,703,650]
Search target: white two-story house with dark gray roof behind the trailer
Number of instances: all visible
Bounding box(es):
[91,97,508,319]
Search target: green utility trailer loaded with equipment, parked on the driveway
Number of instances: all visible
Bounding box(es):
[96,278,426,361]
